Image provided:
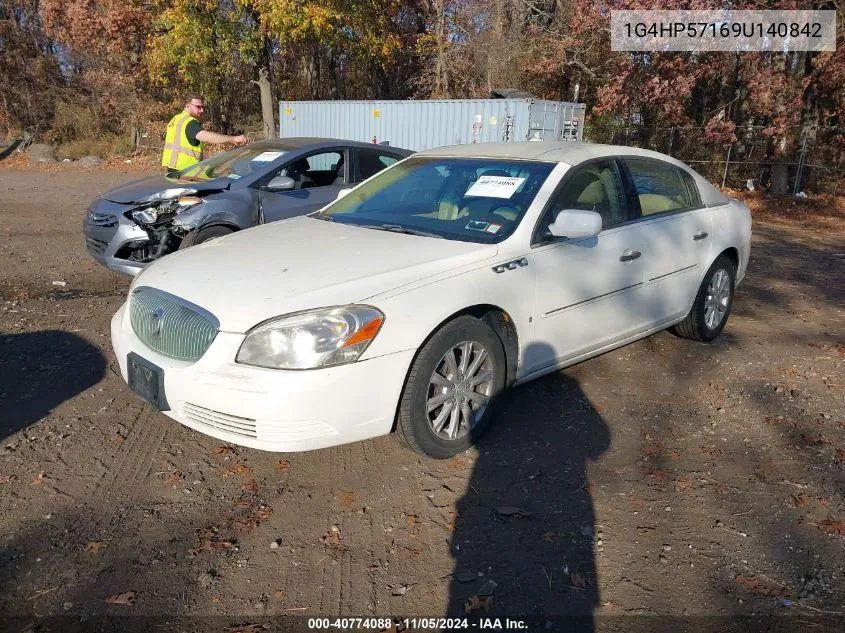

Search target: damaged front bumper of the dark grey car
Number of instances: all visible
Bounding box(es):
[82,199,150,277]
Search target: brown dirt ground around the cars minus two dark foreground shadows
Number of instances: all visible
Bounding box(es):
[0,166,845,632]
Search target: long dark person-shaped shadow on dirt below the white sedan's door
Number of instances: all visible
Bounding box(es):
[447,344,610,631]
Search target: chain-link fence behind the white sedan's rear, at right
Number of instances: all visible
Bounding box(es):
[584,125,845,195]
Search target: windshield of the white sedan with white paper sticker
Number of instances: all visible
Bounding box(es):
[314,156,555,243]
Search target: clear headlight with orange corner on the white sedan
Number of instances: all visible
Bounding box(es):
[235,305,384,369]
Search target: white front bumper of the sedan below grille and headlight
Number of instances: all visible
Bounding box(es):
[111,304,414,452]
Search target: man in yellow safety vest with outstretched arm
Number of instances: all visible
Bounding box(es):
[161,93,247,176]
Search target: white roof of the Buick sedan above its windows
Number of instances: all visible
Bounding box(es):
[416,141,728,206]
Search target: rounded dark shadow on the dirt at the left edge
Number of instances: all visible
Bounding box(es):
[0,330,106,441]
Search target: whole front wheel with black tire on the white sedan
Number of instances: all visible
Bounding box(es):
[396,316,507,459]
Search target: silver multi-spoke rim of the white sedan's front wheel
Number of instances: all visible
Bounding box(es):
[426,341,495,440]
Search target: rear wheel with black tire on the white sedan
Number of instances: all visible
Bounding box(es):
[672,255,736,343]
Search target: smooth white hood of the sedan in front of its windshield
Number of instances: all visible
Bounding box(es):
[133,217,498,332]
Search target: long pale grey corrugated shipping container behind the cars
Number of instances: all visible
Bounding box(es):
[279,98,586,151]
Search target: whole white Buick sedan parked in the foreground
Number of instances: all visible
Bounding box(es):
[112,143,751,458]
